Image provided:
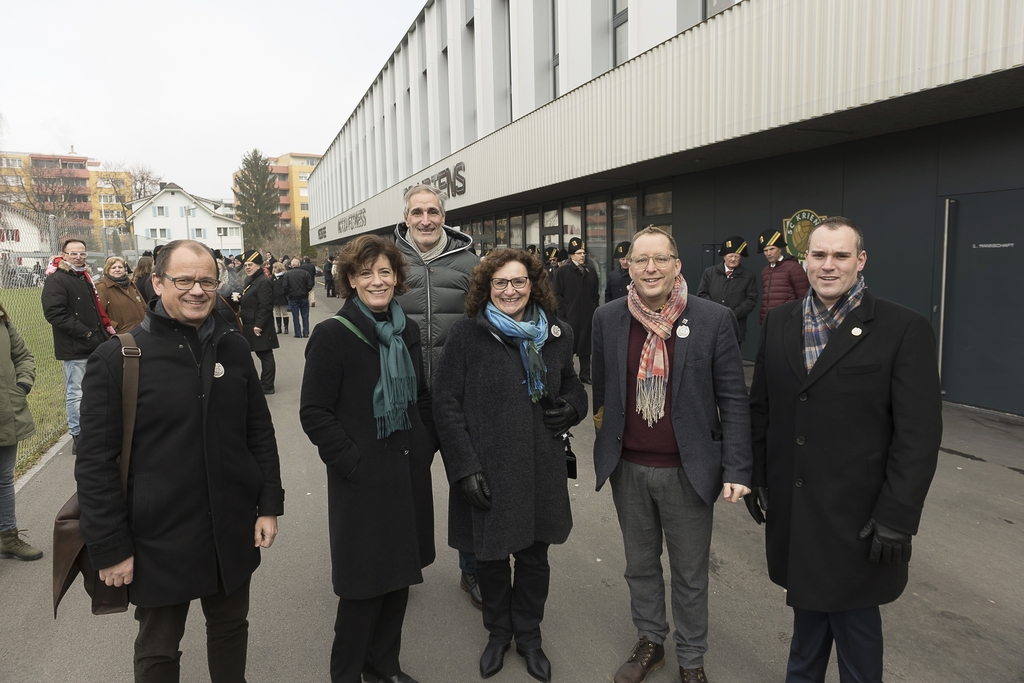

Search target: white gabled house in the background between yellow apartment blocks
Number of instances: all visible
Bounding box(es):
[129,182,243,256]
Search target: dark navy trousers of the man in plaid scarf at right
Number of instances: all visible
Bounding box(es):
[785,607,882,683]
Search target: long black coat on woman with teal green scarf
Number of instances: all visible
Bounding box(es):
[299,297,436,600]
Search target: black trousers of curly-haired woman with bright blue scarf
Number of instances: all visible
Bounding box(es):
[476,543,551,650]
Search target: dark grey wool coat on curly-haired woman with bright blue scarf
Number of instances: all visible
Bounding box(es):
[434,313,587,560]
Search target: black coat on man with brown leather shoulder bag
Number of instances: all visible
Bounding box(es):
[75,310,285,607]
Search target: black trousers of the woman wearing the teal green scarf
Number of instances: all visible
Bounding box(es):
[331,587,409,683]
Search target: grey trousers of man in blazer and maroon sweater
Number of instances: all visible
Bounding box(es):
[610,460,715,669]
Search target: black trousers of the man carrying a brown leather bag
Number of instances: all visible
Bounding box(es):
[135,581,249,683]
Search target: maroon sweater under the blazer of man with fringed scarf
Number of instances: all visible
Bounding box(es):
[623,316,682,467]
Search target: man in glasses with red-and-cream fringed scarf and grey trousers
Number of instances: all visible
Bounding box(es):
[593,226,751,683]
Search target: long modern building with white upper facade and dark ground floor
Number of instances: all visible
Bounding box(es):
[309,0,1024,415]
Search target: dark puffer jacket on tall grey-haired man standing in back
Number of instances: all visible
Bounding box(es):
[394,223,480,385]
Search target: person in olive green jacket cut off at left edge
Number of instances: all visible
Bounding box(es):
[0,305,43,560]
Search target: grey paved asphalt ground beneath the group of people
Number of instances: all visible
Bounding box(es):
[0,296,1024,683]
